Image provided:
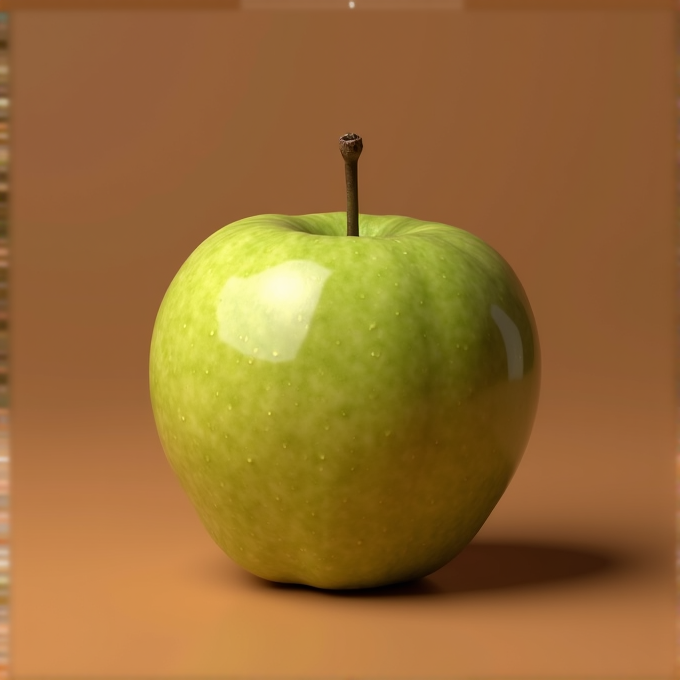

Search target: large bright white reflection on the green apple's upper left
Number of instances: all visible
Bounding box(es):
[217,260,332,362]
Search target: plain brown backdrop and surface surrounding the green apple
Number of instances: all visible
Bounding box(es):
[5,5,675,679]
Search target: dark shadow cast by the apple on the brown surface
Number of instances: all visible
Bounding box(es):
[247,541,633,598]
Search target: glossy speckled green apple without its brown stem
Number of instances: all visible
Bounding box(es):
[150,212,540,589]
